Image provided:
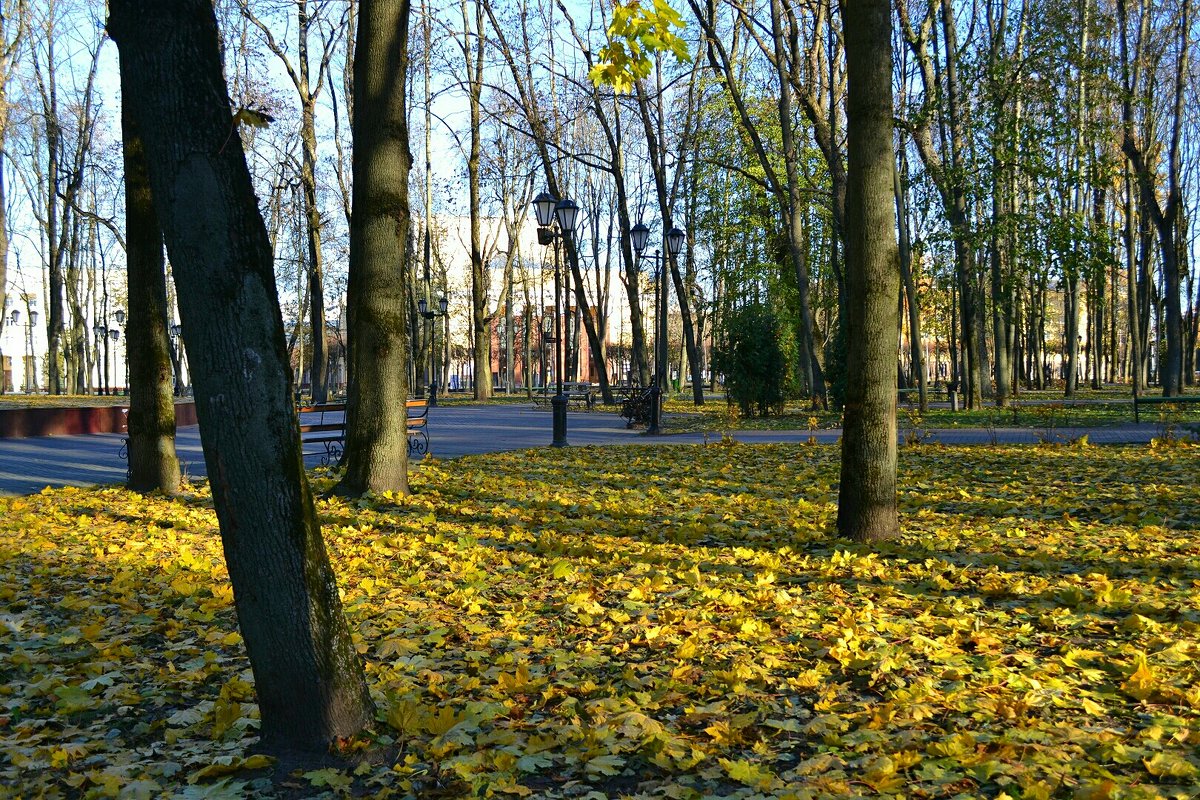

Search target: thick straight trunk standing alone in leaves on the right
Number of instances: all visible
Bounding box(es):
[838,0,900,541]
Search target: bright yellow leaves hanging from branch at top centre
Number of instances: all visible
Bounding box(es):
[588,0,691,94]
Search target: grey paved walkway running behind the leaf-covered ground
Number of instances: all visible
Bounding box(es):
[0,404,1158,497]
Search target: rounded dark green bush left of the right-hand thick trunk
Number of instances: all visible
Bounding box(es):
[713,303,797,416]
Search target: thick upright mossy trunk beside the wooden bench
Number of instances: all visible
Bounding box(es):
[340,0,413,494]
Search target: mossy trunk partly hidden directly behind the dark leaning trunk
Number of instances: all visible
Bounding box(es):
[121,104,179,494]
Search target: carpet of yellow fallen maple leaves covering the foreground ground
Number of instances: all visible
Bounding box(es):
[0,444,1200,799]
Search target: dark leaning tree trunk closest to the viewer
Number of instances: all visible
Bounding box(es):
[108,0,373,753]
